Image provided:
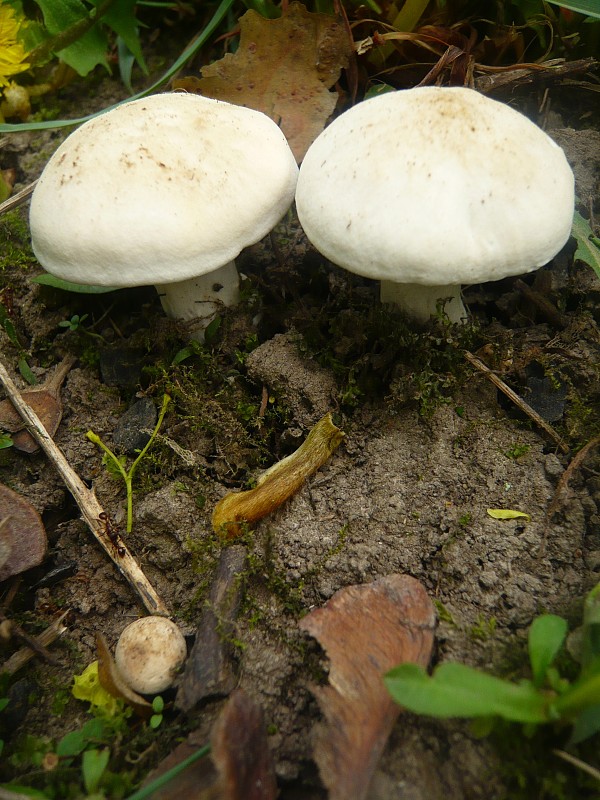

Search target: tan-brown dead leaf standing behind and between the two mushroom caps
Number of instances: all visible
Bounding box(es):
[173,3,352,161]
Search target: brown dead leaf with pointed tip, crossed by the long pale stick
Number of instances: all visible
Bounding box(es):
[0,356,75,453]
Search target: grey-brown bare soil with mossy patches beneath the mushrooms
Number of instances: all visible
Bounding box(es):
[0,50,600,800]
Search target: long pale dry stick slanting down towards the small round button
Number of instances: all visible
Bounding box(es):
[0,362,169,616]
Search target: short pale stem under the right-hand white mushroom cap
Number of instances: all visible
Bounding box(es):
[380,281,468,324]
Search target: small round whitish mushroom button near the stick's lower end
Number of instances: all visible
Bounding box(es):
[115,617,187,694]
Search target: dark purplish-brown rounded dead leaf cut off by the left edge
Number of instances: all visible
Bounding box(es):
[0,484,48,581]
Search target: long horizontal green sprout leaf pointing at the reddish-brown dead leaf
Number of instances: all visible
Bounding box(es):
[384,663,547,723]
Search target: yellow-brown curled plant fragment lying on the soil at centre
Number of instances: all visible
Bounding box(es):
[212,414,345,538]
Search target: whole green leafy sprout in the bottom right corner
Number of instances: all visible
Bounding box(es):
[385,584,600,743]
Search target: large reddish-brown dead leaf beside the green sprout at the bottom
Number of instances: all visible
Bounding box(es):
[299,575,435,800]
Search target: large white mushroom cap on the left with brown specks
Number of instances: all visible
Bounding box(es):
[30,93,298,286]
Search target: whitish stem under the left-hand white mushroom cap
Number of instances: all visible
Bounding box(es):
[156,261,240,342]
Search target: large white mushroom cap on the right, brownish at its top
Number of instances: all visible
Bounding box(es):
[296,87,574,286]
